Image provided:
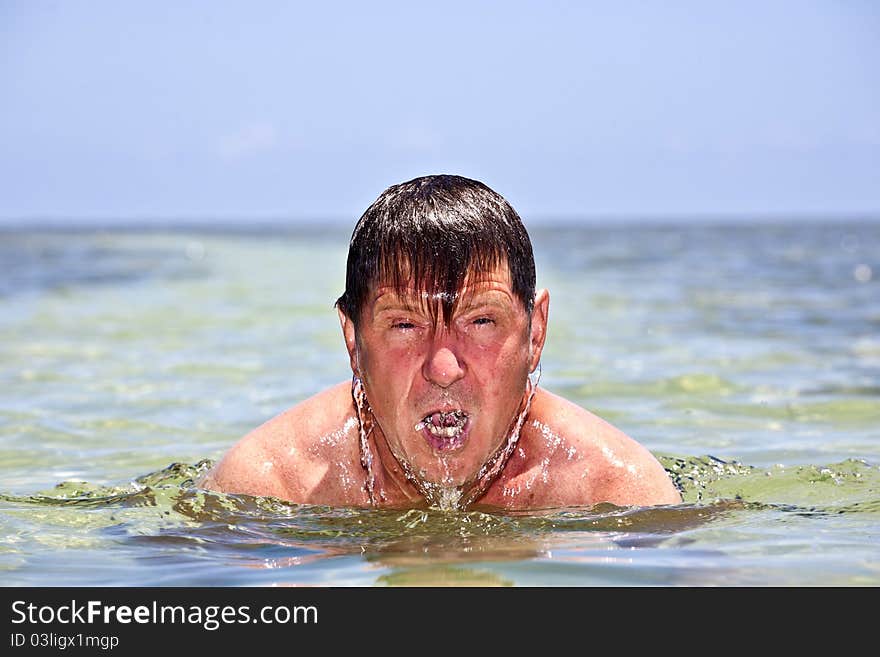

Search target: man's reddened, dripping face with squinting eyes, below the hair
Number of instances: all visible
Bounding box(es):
[340,263,549,486]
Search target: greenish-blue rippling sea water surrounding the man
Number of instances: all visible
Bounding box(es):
[0,221,880,586]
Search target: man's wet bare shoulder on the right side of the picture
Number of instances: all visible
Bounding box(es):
[498,390,681,506]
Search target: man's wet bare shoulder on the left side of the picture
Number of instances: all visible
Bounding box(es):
[199,383,362,504]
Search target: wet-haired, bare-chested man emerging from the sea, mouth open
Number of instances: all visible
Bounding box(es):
[200,175,681,510]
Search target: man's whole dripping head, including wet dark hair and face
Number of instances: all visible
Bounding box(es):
[337,175,549,494]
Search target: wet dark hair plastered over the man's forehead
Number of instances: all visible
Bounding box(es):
[336,175,535,327]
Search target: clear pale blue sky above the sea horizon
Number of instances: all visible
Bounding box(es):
[0,0,880,221]
